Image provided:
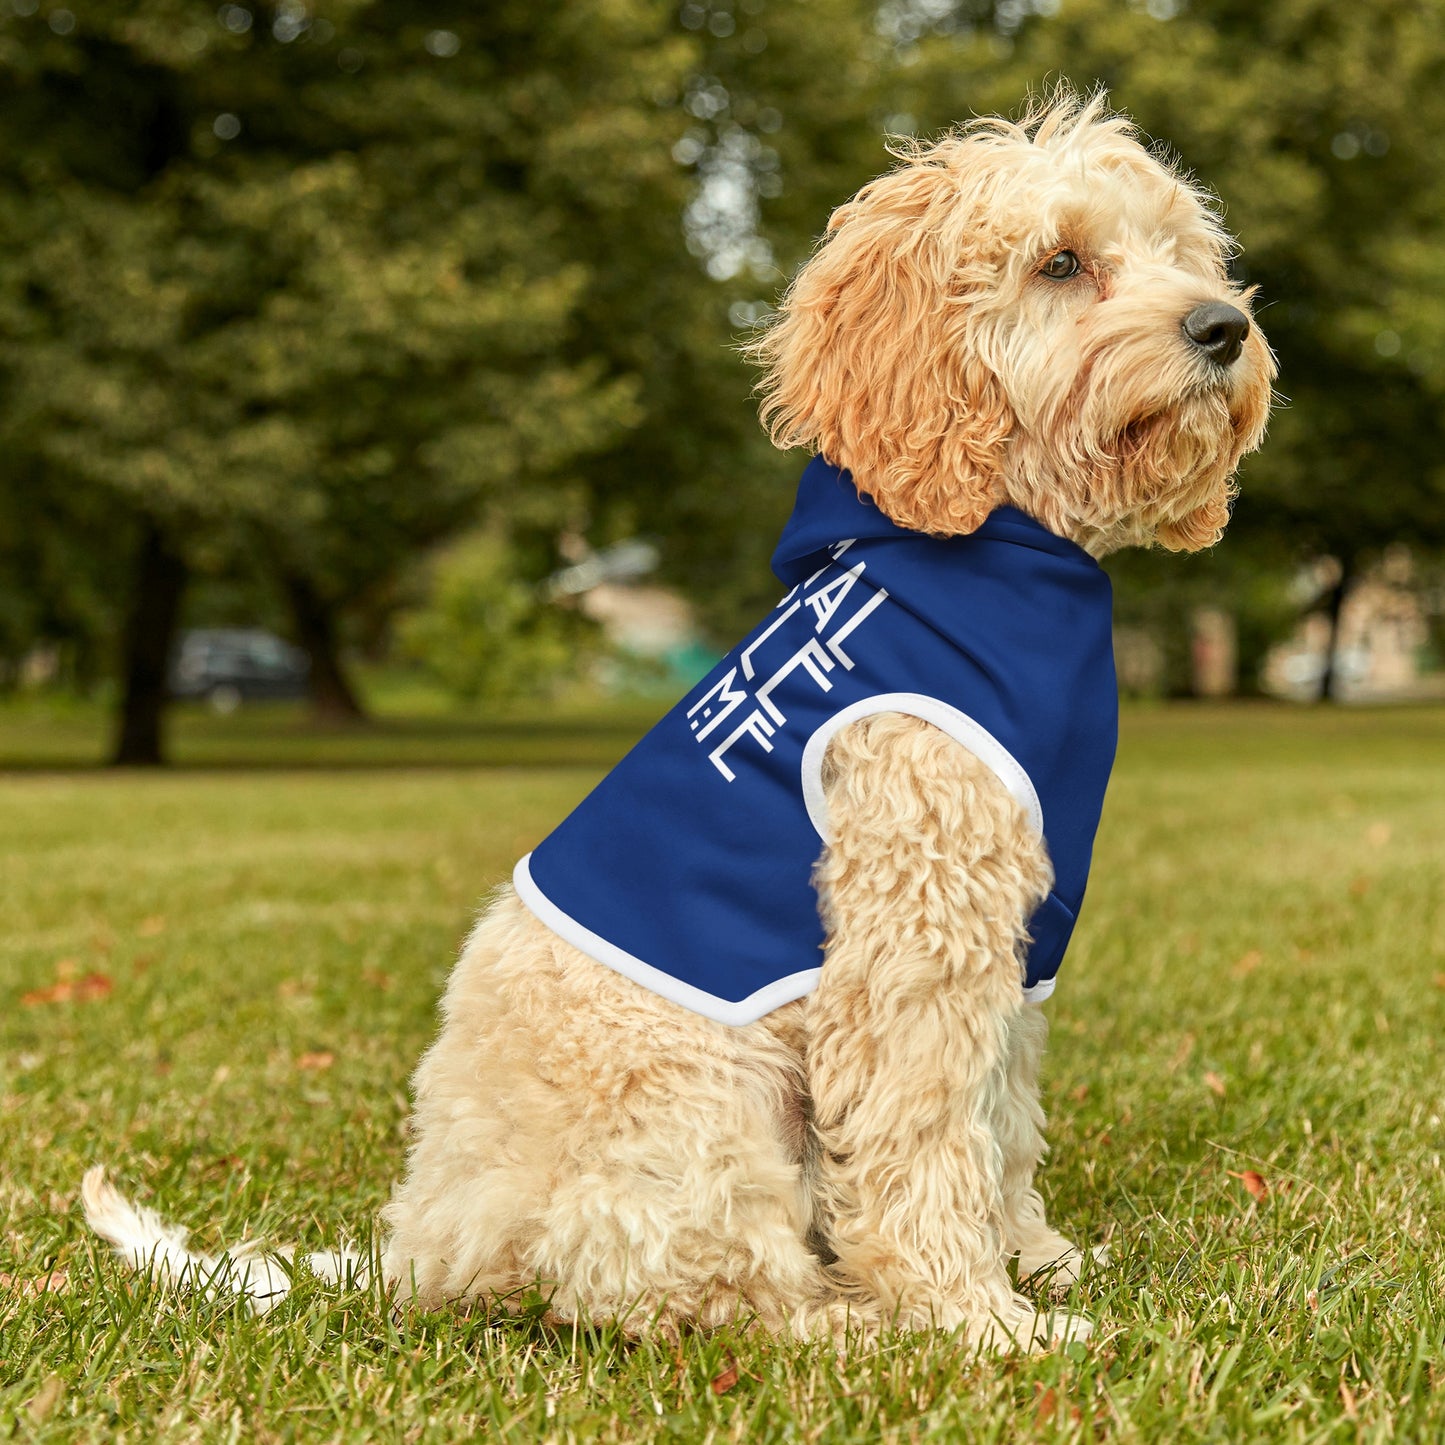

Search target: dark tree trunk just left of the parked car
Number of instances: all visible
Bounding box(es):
[111,522,186,767]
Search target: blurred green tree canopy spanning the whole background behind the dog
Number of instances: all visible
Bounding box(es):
[0,0,1445,762]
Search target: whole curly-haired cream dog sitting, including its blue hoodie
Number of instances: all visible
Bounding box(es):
[87,94,1273,1344]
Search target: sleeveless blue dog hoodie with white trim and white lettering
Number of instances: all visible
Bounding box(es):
[513,457,1118,1025]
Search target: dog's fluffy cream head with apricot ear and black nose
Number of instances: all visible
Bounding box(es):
[751,92,1274,553]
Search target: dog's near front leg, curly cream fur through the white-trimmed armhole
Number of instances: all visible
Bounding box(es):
[808,714,1087,1345]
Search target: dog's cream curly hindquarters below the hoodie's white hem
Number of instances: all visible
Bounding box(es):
[383,889,825,1335]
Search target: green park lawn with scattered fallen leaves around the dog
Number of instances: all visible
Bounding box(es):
[0,707,1445,1442]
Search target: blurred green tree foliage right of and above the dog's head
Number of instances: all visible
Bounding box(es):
[886,0,1445,688]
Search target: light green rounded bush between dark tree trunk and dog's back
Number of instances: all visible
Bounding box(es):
[397,530,597,702]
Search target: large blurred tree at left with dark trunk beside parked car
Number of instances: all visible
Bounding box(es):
[0,0,688,763]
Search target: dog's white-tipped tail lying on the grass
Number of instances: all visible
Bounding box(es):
[81,1165,370,1315]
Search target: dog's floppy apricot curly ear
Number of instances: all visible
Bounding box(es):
[749,151,1013,535]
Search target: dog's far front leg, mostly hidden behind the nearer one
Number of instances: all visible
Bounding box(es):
[994,1003,1084,1290]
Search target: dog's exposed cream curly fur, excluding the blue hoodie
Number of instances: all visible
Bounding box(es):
[87,94,1273,1345]
